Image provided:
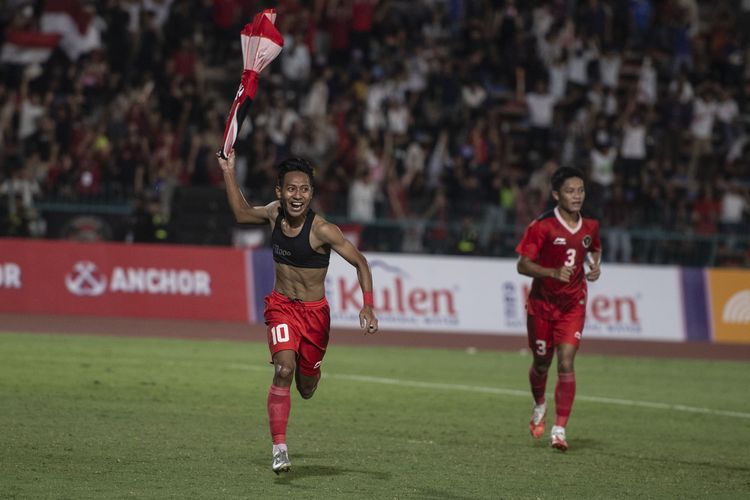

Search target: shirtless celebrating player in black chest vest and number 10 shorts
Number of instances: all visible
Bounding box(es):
[219,150,378,474]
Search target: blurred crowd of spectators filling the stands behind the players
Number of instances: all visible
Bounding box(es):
[0,0,750,266]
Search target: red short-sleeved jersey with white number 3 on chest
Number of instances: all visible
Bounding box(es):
[516,208,602,314]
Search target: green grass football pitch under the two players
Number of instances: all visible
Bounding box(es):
[0,333,750,499]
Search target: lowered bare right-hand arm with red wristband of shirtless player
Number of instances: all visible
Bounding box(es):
[313,222,378,333]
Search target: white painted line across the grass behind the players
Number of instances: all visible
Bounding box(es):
[230,364,750,419]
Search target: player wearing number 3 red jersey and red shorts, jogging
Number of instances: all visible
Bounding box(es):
[516,167,602,451]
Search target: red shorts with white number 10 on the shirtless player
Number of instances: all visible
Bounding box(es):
[263,290,331,376]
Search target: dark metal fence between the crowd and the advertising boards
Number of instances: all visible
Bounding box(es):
[25,189,750,267]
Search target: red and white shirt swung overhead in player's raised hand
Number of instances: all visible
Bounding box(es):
[218,9,284,158]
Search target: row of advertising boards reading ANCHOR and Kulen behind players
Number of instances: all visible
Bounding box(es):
[0,239,750,343]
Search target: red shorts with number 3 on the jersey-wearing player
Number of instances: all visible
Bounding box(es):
[526,300,586,358]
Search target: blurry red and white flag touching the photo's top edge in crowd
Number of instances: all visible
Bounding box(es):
[39,0,102,61]
